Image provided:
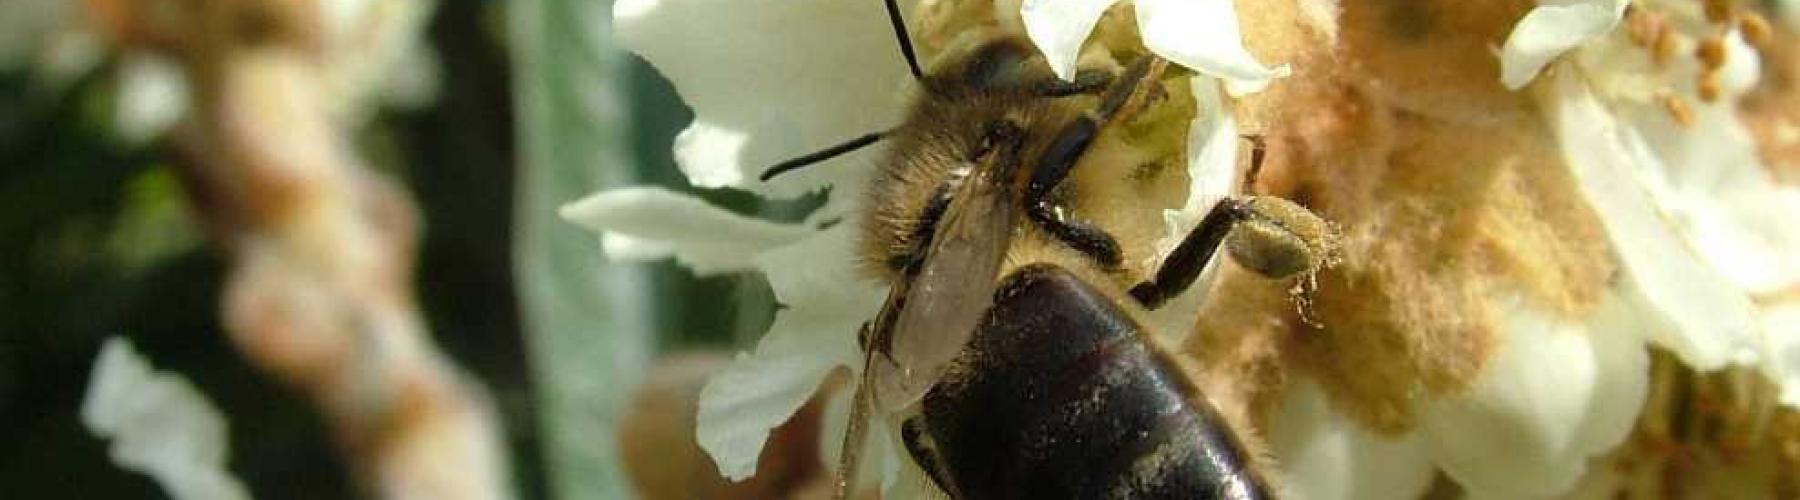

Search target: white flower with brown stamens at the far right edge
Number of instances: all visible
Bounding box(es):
[1501,0,1800,399]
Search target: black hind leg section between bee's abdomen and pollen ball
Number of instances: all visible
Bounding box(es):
[1130,198,1251,309]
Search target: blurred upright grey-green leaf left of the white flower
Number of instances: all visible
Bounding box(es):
[508,0,661,498]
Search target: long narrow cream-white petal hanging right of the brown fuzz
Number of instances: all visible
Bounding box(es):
[1539,70,1759,371]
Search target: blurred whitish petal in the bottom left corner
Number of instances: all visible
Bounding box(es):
[81,338,250,500]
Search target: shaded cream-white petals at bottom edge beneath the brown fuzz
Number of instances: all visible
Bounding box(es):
[1269,291,1649,500]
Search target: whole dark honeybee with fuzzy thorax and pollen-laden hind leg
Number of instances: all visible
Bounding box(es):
[763,0,1325,498]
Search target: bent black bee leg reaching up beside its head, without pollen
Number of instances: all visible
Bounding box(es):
[1024,56,1168,268]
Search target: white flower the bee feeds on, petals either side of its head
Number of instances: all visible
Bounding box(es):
[563,0,1285,487]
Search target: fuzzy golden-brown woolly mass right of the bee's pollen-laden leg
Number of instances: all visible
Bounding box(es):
[1186,2,1615,433]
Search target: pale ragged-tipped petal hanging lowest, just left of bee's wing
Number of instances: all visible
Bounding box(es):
[697,223,882,480]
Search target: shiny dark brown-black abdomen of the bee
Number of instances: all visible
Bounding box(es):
[913,264,1267,498]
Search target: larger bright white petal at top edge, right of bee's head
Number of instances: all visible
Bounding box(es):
[1138,0,1291,95]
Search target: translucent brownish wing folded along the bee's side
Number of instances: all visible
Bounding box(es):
[869,165,1013,410]
